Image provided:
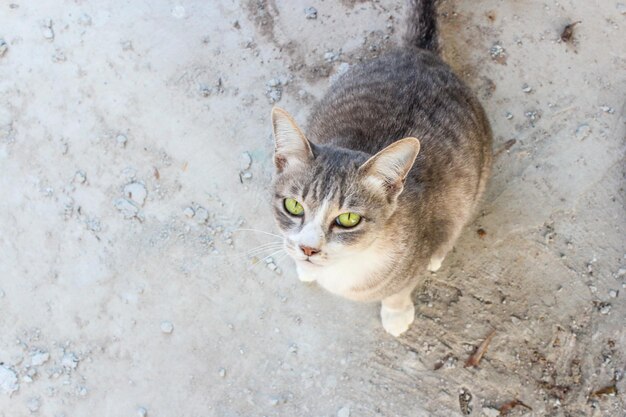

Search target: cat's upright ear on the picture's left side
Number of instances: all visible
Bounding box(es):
[272,107,313,172]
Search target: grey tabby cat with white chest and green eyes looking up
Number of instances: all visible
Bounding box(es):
[271,0,492,336]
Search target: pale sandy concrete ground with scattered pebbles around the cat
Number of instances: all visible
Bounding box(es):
[0,0,626,417]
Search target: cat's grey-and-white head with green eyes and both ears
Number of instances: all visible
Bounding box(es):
[272,108,419,266]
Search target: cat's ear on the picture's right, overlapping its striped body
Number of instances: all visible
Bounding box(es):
[359,138,420,201]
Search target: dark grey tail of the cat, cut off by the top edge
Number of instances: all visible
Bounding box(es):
[403,0,439,53]
